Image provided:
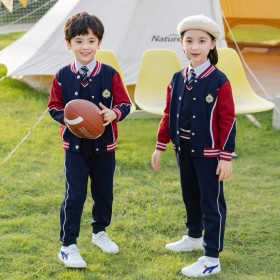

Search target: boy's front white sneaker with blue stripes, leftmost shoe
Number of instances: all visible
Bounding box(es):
[58,244,87,268]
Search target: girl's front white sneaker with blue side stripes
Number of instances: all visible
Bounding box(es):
[181,256,221,277]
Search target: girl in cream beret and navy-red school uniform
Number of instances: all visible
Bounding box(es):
[152,15,235,277]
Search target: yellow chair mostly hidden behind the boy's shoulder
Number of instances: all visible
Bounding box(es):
[95,49,136,113]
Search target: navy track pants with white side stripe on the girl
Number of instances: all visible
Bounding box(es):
[177,140,226,258]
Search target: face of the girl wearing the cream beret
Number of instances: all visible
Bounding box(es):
[181,29,216,67]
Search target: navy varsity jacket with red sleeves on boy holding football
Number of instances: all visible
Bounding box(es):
[48,61,131,154]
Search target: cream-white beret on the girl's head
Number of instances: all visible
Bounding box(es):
[177,15,221,39]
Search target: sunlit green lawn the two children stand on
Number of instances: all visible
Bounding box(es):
[0,32,280,280]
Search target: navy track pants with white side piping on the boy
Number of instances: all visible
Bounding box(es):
[60,151,115,246]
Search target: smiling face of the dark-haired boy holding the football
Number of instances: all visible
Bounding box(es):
[66,29,101,65]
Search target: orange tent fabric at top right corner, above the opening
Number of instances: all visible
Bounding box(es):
[220,0,280,28]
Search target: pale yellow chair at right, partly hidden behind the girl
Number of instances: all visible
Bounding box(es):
[217,48,274,114]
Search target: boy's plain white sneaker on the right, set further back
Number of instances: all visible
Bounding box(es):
[92,231,120,254]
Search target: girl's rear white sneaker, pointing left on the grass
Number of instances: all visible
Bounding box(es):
[165,235,204,252]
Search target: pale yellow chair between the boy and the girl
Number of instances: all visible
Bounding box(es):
[134,49,182,115]
